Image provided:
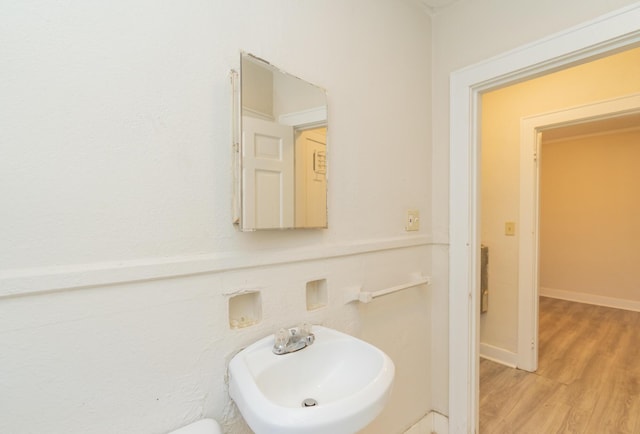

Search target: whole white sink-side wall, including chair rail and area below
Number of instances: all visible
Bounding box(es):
[0,0,432,433]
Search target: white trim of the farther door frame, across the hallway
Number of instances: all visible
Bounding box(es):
[517,94,640,371]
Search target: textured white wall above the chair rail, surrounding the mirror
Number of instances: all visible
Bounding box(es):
[0,0,430,268]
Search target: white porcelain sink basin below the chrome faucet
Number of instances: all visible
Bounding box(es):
[229,326,395,434]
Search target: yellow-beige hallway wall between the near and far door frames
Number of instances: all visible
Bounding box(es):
[480,49,640,352]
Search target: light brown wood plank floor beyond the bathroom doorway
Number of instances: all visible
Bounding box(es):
[480,297,640,434]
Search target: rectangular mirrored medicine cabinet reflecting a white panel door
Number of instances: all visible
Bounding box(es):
[232,53,328,231]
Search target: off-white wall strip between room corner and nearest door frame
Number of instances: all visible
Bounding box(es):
[431,0,635,414]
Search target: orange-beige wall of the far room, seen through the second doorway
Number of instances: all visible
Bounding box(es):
[540,129,640,301]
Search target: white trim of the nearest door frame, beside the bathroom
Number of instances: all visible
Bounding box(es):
[449,3,640,433]
